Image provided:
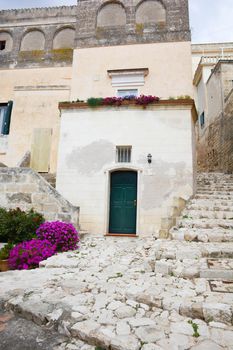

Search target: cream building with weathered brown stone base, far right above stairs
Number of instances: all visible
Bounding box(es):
[192,43,233,173]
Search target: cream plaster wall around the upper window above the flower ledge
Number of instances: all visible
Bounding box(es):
[71,42,193,100]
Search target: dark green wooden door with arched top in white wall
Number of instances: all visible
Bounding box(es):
[109,171,137,234]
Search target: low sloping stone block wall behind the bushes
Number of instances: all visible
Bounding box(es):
[0,167,79,227]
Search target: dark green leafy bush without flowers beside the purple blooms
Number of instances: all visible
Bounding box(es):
[0,208,44,243]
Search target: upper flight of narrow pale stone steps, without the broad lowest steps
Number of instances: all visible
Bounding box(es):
[170,173,233,242]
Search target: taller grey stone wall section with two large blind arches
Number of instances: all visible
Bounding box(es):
[76,0,191,48]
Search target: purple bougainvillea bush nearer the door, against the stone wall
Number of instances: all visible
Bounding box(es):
[36,221,79,252]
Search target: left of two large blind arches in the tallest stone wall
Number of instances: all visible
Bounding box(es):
[97,2,126,27]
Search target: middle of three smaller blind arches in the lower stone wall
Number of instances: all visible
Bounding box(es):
[20,29,45,51]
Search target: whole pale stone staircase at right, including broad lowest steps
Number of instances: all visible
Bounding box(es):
[163,173,233,287]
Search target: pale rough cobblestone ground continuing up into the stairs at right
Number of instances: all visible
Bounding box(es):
[0,174,233,350]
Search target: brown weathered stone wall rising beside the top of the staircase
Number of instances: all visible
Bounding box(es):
[197,90,233,173]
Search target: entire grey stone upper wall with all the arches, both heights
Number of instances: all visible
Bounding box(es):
[0,0,191,68]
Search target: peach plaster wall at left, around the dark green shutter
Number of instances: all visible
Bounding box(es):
[0,67,71,172]
